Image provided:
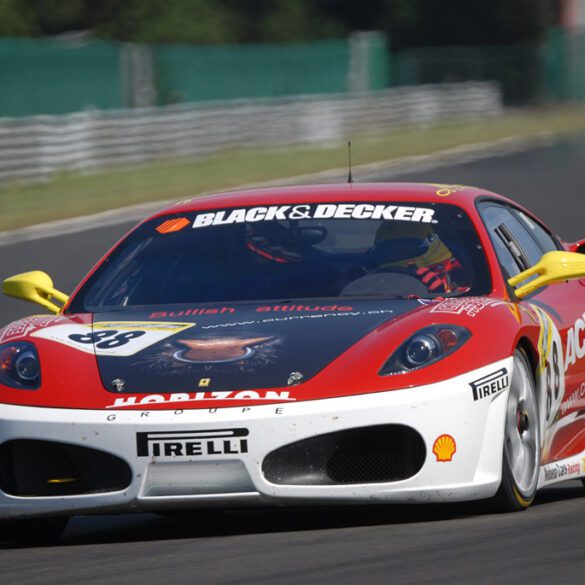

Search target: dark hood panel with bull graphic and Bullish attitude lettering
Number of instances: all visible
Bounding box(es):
[86,300,422,394]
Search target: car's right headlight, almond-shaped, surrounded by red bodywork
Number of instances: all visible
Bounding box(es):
[380,325,471,376]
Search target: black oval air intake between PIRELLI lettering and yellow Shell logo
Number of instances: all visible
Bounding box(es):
[262,425,426,485]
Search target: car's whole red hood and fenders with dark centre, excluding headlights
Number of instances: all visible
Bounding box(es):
[0,297,528,408]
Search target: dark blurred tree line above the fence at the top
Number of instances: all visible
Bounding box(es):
[0,0,561,50]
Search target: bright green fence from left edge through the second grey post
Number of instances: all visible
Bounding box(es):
[0,33,388,117]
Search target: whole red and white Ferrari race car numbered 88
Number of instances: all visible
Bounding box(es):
[0,183,585,538]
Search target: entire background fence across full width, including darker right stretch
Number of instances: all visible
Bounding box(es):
[0,29,585,117]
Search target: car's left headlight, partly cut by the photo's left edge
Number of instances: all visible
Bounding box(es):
[0,341,41,390]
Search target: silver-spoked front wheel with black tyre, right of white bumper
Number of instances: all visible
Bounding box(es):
[495,350,540,512]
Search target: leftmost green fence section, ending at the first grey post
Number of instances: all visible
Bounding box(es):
[0,38,124,116]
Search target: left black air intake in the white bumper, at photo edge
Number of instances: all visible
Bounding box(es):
[0,439,132,497]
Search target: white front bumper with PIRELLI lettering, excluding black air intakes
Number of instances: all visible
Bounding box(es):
[0,358,512,518]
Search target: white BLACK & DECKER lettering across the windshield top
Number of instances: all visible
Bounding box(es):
[193,203,435,229]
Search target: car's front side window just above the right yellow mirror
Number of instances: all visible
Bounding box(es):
[480,203,544,276]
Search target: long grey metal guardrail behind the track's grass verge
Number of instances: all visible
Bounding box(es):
[0,82,502,183]
